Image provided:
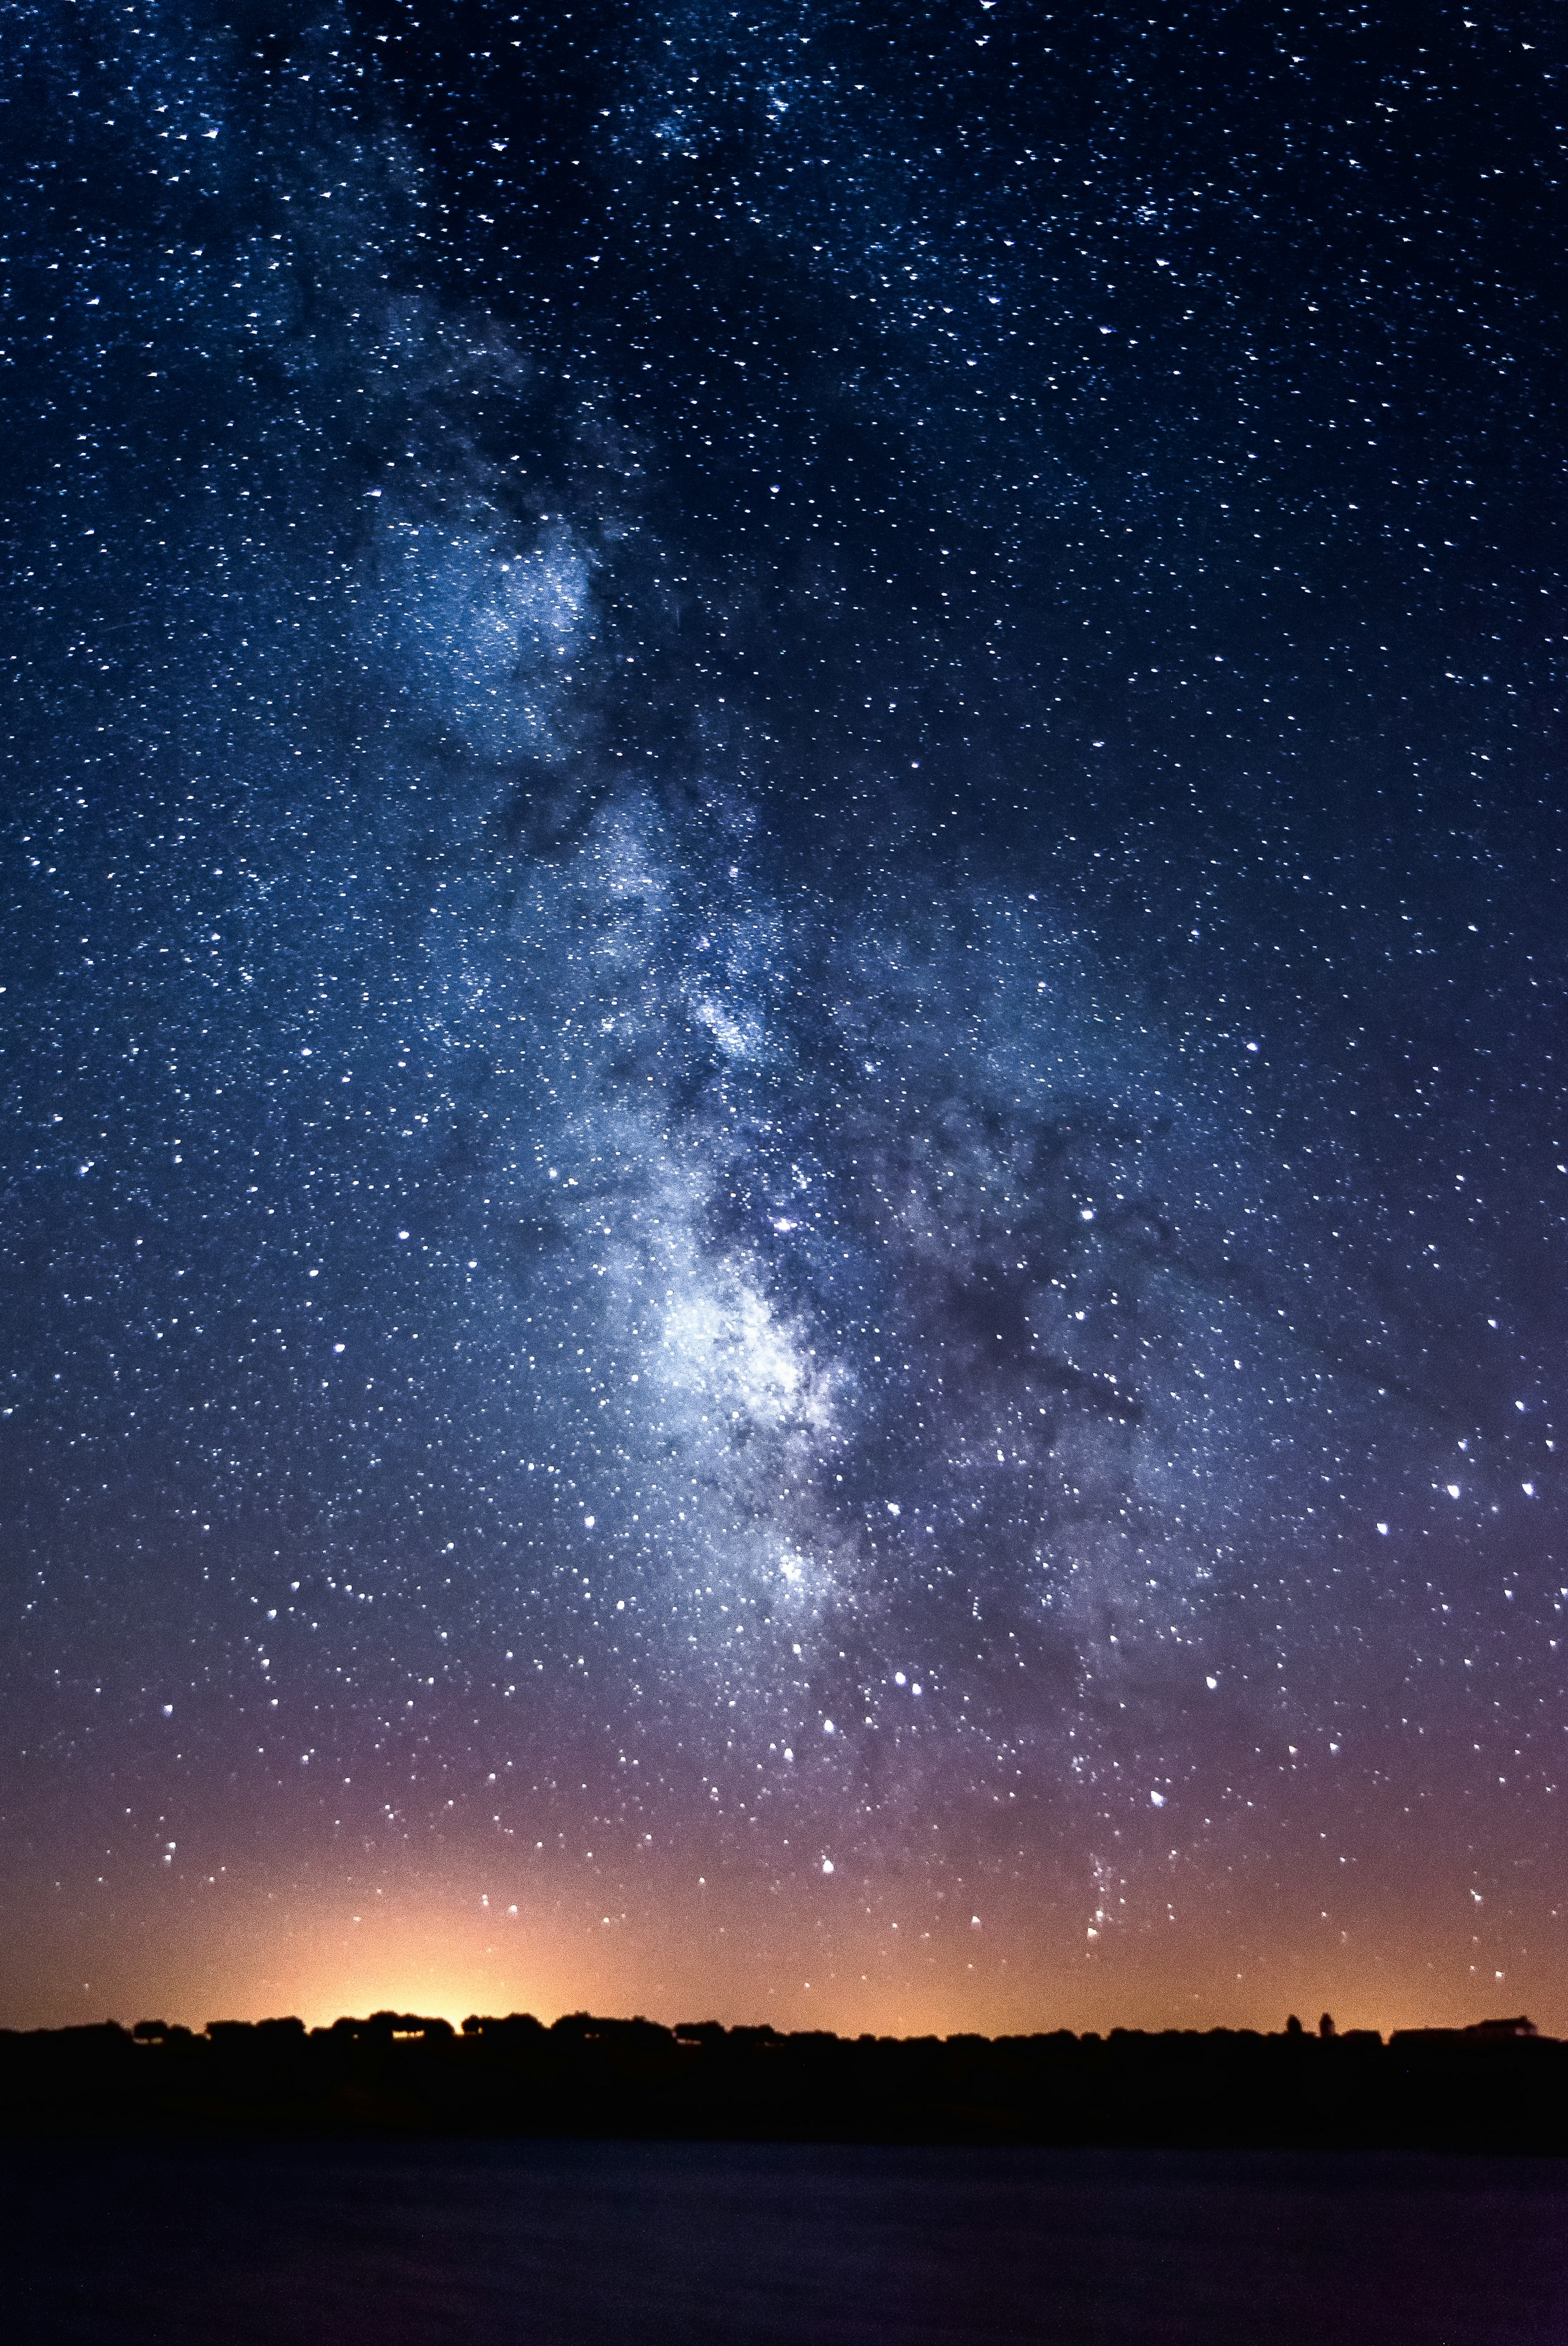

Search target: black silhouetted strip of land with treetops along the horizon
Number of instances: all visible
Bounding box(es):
[0,2013,1568,2154]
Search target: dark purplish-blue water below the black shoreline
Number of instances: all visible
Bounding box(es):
[0,2142,1568,2346]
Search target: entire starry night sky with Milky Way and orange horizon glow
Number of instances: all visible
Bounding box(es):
[0,0,1568,2032]
